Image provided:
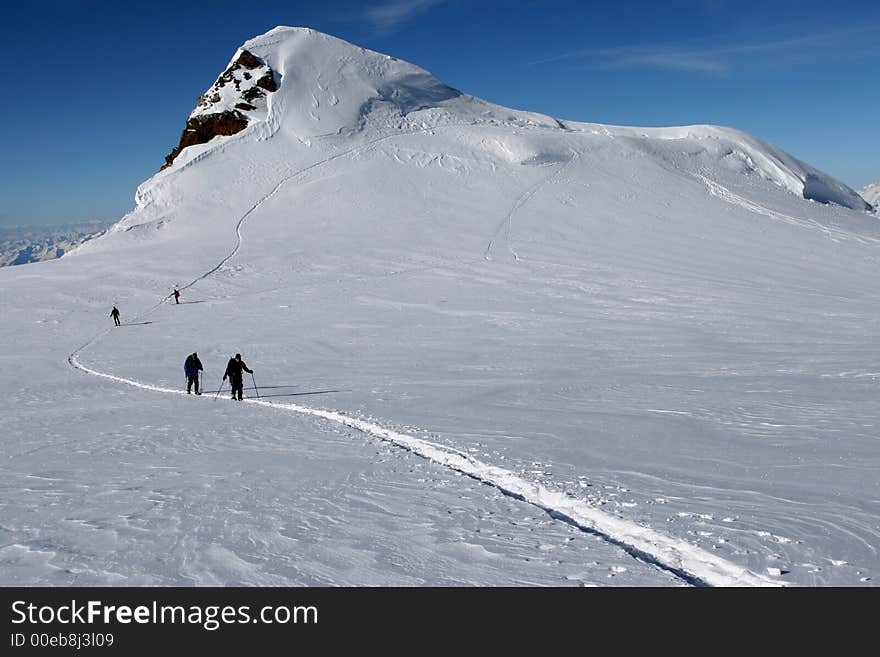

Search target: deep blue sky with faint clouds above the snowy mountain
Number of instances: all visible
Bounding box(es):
[0,0,880,225]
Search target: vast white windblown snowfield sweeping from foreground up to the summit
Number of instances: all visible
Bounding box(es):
[0,28,880,586]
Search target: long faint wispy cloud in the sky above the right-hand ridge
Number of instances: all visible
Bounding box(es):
[533,30,861,77]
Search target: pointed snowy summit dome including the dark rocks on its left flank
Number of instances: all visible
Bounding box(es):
[163,26,481,168]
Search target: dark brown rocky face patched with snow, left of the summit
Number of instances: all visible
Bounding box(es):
[162,50,278,169]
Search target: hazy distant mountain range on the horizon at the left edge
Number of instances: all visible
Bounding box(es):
[0,221,112,267]
